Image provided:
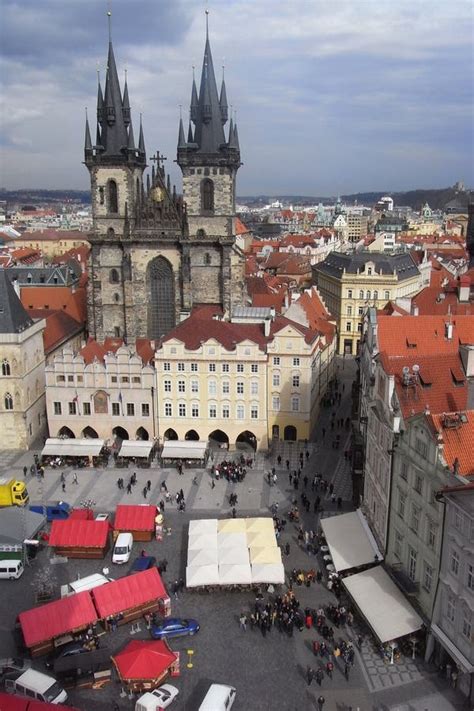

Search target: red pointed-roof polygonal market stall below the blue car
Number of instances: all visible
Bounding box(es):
[112,639,179,693]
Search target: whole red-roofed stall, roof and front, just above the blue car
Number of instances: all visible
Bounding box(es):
[91,568,171,629]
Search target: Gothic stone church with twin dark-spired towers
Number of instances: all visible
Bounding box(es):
[84,20,245,341]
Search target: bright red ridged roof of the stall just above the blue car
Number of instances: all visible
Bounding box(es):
[92,568,168,618]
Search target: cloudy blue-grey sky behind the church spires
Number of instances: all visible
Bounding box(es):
[0,0,474,195]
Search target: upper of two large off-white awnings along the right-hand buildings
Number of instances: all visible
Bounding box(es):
[321,509,383,572]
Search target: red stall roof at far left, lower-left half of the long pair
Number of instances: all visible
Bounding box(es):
[18,588,98,647]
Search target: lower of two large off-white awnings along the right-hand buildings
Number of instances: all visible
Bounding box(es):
[342,565,423,642]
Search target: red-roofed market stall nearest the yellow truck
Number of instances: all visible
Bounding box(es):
[49,518,110,558]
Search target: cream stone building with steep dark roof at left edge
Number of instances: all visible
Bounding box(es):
[0,269,46,449]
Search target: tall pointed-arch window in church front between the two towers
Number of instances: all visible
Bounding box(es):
[147,256,176,339]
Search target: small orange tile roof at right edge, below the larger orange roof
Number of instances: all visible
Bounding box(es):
[429,410,474,476]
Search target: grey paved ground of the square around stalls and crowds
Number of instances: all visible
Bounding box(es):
[0,359,468,711]
